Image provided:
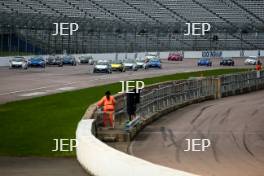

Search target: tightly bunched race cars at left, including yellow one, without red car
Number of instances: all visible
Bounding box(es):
[9,55,162,73]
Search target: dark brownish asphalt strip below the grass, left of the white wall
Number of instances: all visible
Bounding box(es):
[0,157,88,176]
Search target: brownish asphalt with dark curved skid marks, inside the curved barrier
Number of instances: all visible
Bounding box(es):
[129,91,264,176]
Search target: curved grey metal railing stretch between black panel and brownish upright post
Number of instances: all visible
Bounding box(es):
[137,78,216,118]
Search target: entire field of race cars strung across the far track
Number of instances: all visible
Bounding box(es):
[9,53,258,73]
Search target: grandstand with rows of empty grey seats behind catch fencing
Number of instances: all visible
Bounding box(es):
[0,0,264,53]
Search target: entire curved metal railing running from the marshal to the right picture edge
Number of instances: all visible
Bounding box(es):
[94,71,264,129]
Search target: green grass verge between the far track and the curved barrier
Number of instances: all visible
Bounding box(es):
[0,69,249,156]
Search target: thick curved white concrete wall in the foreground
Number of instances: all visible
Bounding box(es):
[76,119,195,176]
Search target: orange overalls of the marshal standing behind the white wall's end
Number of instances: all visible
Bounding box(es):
[97,96,115,128]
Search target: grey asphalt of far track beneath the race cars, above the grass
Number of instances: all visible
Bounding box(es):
[0,59,253,104]
